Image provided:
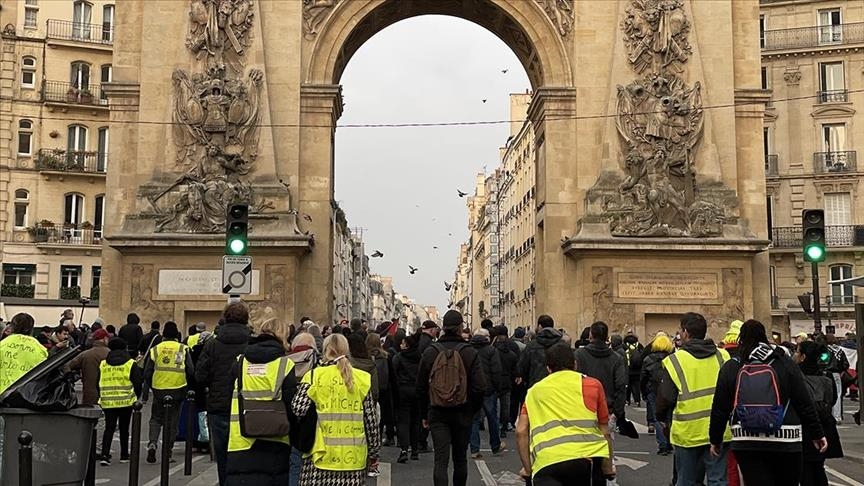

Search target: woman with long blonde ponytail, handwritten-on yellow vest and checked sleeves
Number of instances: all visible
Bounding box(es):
[291,334,381,486]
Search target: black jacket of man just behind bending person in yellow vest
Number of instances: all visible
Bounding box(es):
[575,340,628,420]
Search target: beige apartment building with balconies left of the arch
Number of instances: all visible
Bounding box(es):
[0,0,114,324]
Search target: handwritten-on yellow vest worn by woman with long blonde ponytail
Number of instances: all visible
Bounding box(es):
[302,364,372,471]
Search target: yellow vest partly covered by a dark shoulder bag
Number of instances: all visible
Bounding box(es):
[228,356,294,452]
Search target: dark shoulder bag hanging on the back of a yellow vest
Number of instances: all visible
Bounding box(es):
[237,357,291,439]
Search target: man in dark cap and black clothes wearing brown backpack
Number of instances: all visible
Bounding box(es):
[417,309,487,486]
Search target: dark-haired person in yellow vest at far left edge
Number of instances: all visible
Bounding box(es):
[0,312,48,393]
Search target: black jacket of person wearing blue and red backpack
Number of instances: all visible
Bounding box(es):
[709,344,825,452]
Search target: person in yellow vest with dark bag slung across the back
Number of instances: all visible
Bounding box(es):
[225,319,297,486]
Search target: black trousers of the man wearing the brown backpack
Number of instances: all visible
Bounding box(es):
[429,409,471,486]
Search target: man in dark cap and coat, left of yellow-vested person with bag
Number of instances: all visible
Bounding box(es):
[195,302,251,486]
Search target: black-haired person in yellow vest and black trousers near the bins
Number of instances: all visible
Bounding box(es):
[98,338,144,466]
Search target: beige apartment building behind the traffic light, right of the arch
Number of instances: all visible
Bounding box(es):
[760,0,864,335]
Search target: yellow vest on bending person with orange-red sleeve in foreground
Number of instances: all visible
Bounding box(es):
[525,370,609,475]
